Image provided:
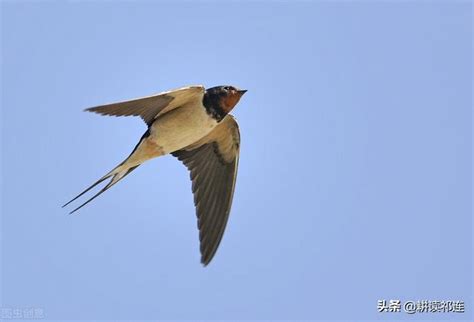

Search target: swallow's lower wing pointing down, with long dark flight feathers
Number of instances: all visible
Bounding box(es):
[172,115,240,266]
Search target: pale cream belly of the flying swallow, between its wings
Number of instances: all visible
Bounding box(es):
[149,105,217,154]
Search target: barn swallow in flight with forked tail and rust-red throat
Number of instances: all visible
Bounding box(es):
[63,86,246,266]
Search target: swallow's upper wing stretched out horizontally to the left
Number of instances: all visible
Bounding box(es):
[86,85,205,126]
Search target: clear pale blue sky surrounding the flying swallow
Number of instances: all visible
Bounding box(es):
[1,1,473,321]
